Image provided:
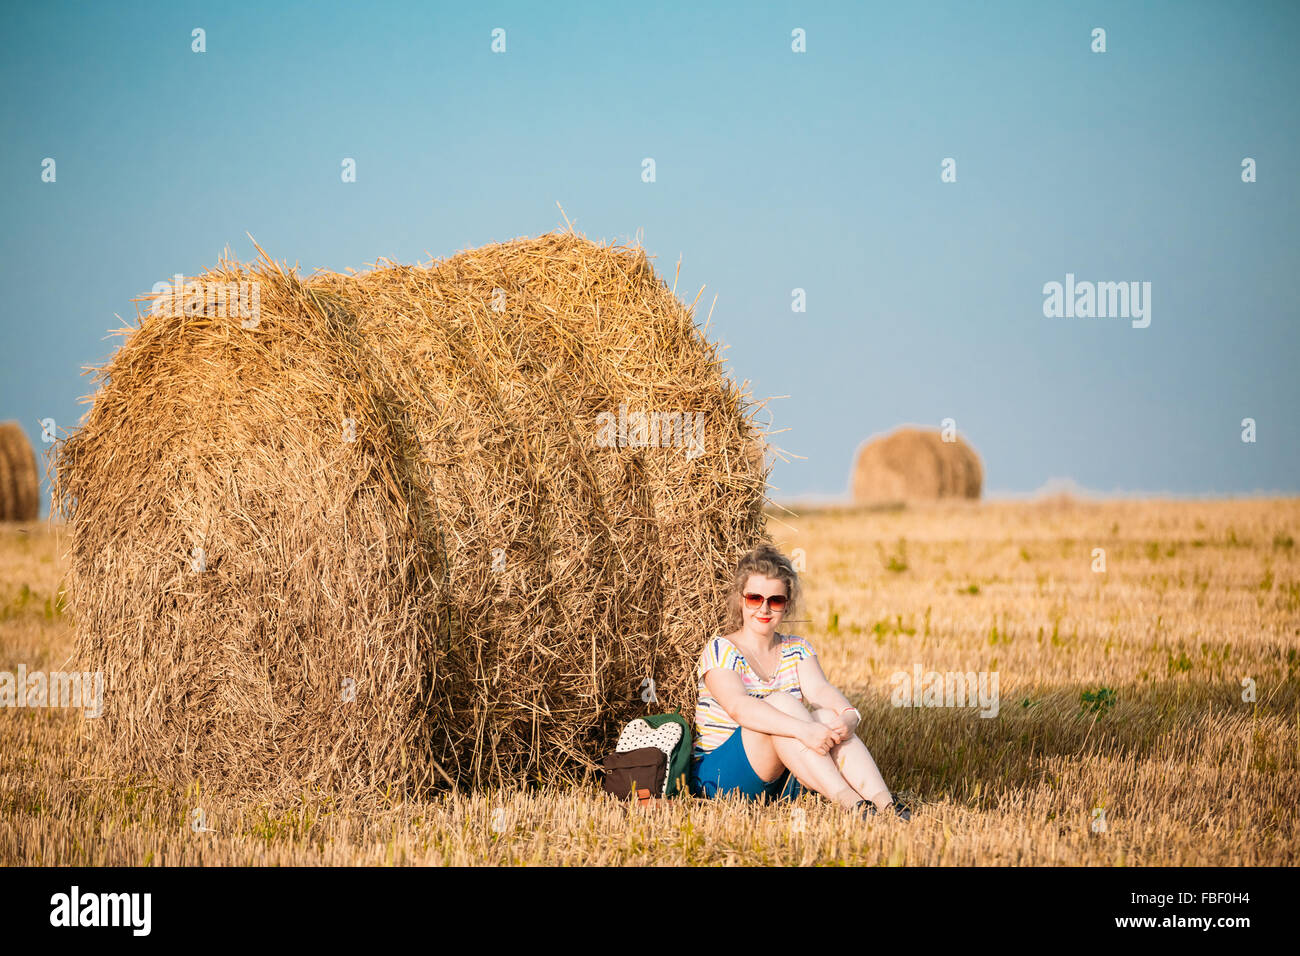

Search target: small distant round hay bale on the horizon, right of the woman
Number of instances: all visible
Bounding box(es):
[853,427,984,505]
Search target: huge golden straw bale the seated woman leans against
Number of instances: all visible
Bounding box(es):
[55,233,767,793]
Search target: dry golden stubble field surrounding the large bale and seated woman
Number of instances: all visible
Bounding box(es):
[0,499,1300,866]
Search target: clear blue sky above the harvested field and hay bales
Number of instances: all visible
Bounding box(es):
[0,1,1300,514]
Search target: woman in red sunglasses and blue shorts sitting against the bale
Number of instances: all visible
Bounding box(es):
[690,545,911,819]
